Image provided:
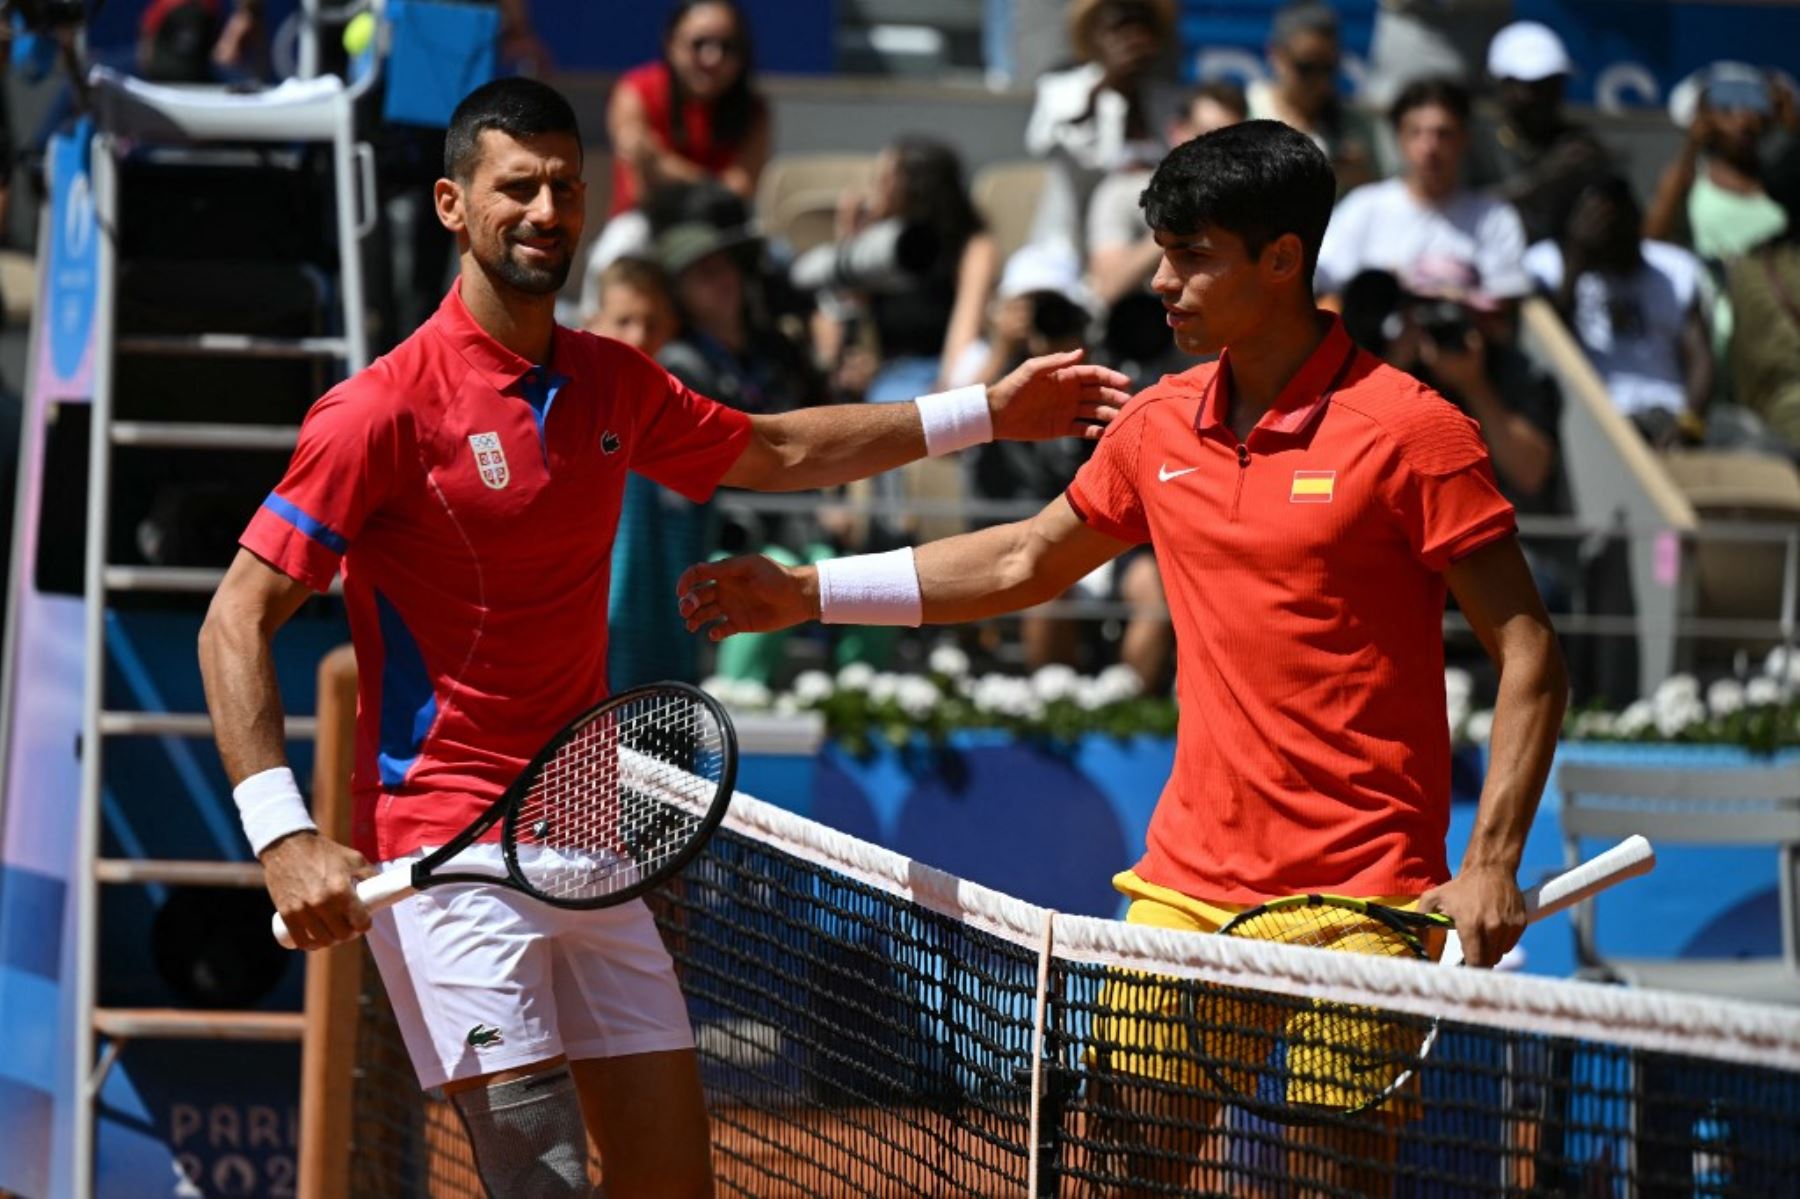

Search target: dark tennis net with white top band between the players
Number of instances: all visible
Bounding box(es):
[338,796,1800,1199]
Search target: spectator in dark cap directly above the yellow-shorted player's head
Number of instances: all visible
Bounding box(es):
[1249,0,1381,194]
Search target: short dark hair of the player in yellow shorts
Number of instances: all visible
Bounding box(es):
[1139,121,1337,286]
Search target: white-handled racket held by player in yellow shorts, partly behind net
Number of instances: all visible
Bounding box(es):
[1193,837,1656,1123]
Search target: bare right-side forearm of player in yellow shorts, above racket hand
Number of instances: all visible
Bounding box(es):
[1462,618,1568,875]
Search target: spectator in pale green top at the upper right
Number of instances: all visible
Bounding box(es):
[1643,63,1787,261]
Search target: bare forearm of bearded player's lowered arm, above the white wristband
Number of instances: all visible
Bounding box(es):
[200,603,288,787]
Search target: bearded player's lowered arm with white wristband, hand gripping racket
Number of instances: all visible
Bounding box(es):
[200,549,373,949]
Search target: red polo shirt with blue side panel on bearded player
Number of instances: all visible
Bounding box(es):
[243,284,751,861]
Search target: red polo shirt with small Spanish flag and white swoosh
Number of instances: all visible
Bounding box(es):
[1067,317,1514,904]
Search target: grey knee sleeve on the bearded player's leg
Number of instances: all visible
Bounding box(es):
[454,1066,594,1199]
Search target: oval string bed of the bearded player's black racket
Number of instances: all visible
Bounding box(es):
[515,693,725,902]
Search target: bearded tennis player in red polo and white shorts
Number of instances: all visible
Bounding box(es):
[200,79,1125,1199]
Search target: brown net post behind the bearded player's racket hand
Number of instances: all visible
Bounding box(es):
[297,645,364,1199]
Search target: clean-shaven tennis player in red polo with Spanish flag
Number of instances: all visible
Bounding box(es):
[680,121,1566,1188]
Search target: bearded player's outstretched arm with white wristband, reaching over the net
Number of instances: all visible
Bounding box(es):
[722,349,1130,491]
